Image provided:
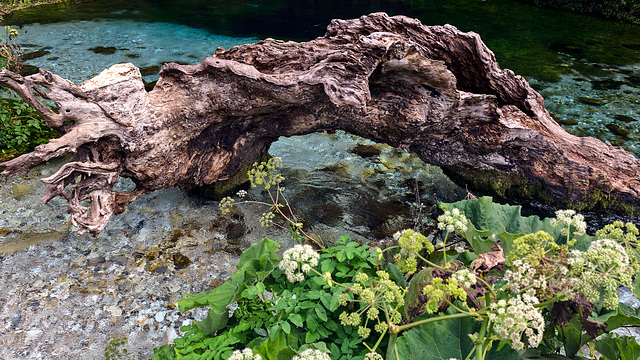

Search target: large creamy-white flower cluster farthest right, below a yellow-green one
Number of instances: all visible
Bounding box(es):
[570,239,635,309]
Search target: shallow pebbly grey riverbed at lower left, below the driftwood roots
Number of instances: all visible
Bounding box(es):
[0,156,260,360]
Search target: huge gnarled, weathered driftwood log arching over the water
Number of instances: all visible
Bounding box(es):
[0,13,640,235]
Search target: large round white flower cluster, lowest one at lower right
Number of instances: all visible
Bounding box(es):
[489,294,544,350]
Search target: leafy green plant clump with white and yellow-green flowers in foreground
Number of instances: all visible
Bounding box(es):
[154,160,640,360]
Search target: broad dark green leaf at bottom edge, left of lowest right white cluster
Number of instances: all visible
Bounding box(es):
[396,310,520,360]
